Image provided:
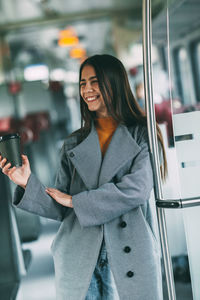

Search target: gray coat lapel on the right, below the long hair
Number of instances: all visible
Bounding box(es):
[99,124,141,186]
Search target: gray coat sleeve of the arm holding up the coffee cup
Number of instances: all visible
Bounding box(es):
[13,145,71,221]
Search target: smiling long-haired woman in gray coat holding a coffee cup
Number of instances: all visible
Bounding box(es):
[0,55,166,300]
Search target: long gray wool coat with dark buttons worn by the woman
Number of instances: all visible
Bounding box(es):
[14,124,162,300]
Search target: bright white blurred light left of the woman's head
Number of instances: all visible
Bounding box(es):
[24,64,49,81]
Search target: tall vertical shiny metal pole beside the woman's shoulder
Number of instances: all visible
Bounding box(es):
[143,0,176,300]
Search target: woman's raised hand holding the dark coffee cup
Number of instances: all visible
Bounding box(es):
[0,155,31,189]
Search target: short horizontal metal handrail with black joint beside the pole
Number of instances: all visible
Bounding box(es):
[156,196,200,209]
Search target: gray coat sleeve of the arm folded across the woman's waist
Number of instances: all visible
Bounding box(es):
[72,135,153,226]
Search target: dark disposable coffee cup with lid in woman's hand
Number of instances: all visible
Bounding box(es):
[0,133,22,167]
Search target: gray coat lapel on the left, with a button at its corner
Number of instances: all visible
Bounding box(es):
[67,124,102,190]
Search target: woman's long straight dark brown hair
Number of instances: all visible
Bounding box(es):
[79,54,167,179]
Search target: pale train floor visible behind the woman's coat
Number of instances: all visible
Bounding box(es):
[16,219,192,300]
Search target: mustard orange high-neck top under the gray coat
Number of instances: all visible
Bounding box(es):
[95,117,118,156]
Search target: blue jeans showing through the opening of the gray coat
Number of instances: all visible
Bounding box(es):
[85,240,119,300]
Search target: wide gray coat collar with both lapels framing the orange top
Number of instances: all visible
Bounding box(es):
[67,124,141,190]
